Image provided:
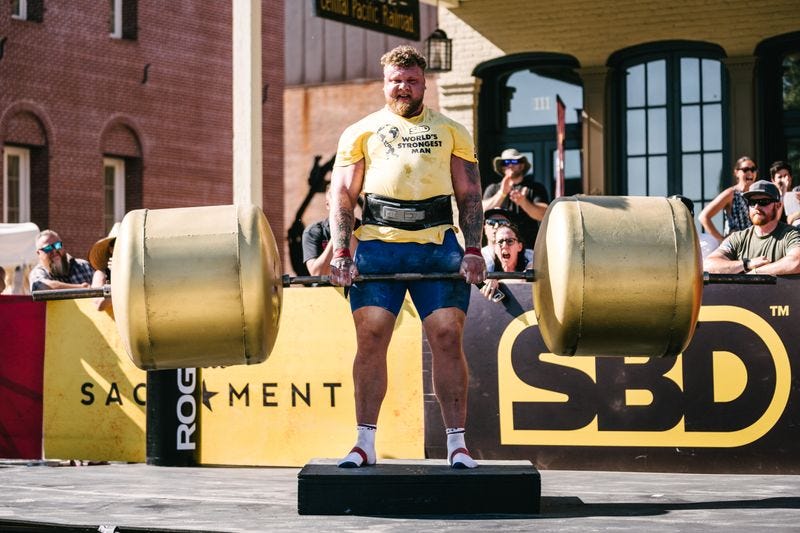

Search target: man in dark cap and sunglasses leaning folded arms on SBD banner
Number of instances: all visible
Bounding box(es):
[703,180,800,276]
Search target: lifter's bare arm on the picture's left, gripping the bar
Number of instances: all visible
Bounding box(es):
[330,159,365,286]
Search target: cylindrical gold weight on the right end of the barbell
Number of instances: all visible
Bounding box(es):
[533,196,703,357]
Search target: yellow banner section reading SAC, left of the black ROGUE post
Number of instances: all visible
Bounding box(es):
[43,300,147,462]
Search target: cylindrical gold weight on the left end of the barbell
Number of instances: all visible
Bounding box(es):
[111,205,283,370]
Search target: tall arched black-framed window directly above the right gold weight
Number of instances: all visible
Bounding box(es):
[609,43,728,229]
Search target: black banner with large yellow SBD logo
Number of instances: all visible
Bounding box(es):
[424,279,800,474]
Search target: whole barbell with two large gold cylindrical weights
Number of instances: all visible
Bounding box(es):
[33,196,775,370]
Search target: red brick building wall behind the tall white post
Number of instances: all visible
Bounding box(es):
[0,0,284,264]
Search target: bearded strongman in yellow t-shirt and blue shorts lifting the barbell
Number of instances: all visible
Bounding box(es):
[331,46,486,468]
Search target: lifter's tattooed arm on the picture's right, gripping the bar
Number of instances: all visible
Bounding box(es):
[450,156,486,283]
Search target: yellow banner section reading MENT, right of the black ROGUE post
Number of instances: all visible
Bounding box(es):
[200,287,425,466]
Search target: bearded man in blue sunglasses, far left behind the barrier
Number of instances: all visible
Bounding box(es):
[29,229,94,291]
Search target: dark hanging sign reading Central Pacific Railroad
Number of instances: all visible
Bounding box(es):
[314,0,419,41]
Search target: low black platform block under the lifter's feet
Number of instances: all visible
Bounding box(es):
[297,459,542,516]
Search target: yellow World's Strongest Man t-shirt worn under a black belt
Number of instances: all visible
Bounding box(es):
[334,107,476,244]
